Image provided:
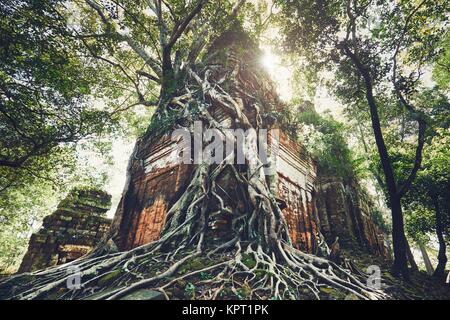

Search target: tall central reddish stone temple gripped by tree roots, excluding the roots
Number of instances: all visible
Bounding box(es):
[108,30,382,253]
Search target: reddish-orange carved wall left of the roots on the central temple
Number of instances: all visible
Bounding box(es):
[115,134,194,250]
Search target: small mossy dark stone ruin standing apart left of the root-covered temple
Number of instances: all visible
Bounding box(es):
[19,189,111,272]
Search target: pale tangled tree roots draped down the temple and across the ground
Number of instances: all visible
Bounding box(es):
[0,69,388,300]
